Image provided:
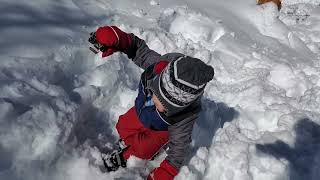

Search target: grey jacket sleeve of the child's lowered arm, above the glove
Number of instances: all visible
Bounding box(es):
[166,115,197,170]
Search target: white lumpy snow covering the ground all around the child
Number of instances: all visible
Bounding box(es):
[0,0,320,180]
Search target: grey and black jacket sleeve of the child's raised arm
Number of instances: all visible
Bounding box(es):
[124,34,161,69]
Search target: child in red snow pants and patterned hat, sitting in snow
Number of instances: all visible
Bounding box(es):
[95,26,214,180]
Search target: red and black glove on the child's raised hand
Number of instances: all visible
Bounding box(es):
[96,26,132,57]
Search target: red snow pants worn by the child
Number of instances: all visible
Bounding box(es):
[116,107,169,159]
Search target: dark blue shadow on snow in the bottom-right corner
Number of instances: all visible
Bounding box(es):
[256,119,320,180]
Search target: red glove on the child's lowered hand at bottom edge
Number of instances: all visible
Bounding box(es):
[147,160,178,180]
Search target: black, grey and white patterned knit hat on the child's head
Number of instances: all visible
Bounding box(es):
[147,56,214,116]
